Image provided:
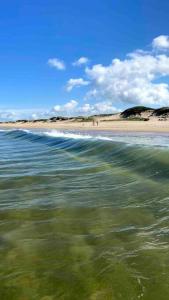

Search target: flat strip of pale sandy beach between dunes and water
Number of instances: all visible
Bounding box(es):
[0,121,169,133]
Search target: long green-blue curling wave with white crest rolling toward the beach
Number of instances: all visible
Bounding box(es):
[3,130,169,180]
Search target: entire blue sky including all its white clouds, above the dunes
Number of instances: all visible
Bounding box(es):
[0,0,169,120]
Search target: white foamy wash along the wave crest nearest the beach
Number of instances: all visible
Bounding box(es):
[0,129,169,147]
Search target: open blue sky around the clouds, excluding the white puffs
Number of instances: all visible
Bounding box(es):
[0,0,169,119]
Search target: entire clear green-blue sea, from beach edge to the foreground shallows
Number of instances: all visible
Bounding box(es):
[0,130,169,300]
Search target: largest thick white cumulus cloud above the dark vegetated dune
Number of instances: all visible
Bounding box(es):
[86,52,169,105]
